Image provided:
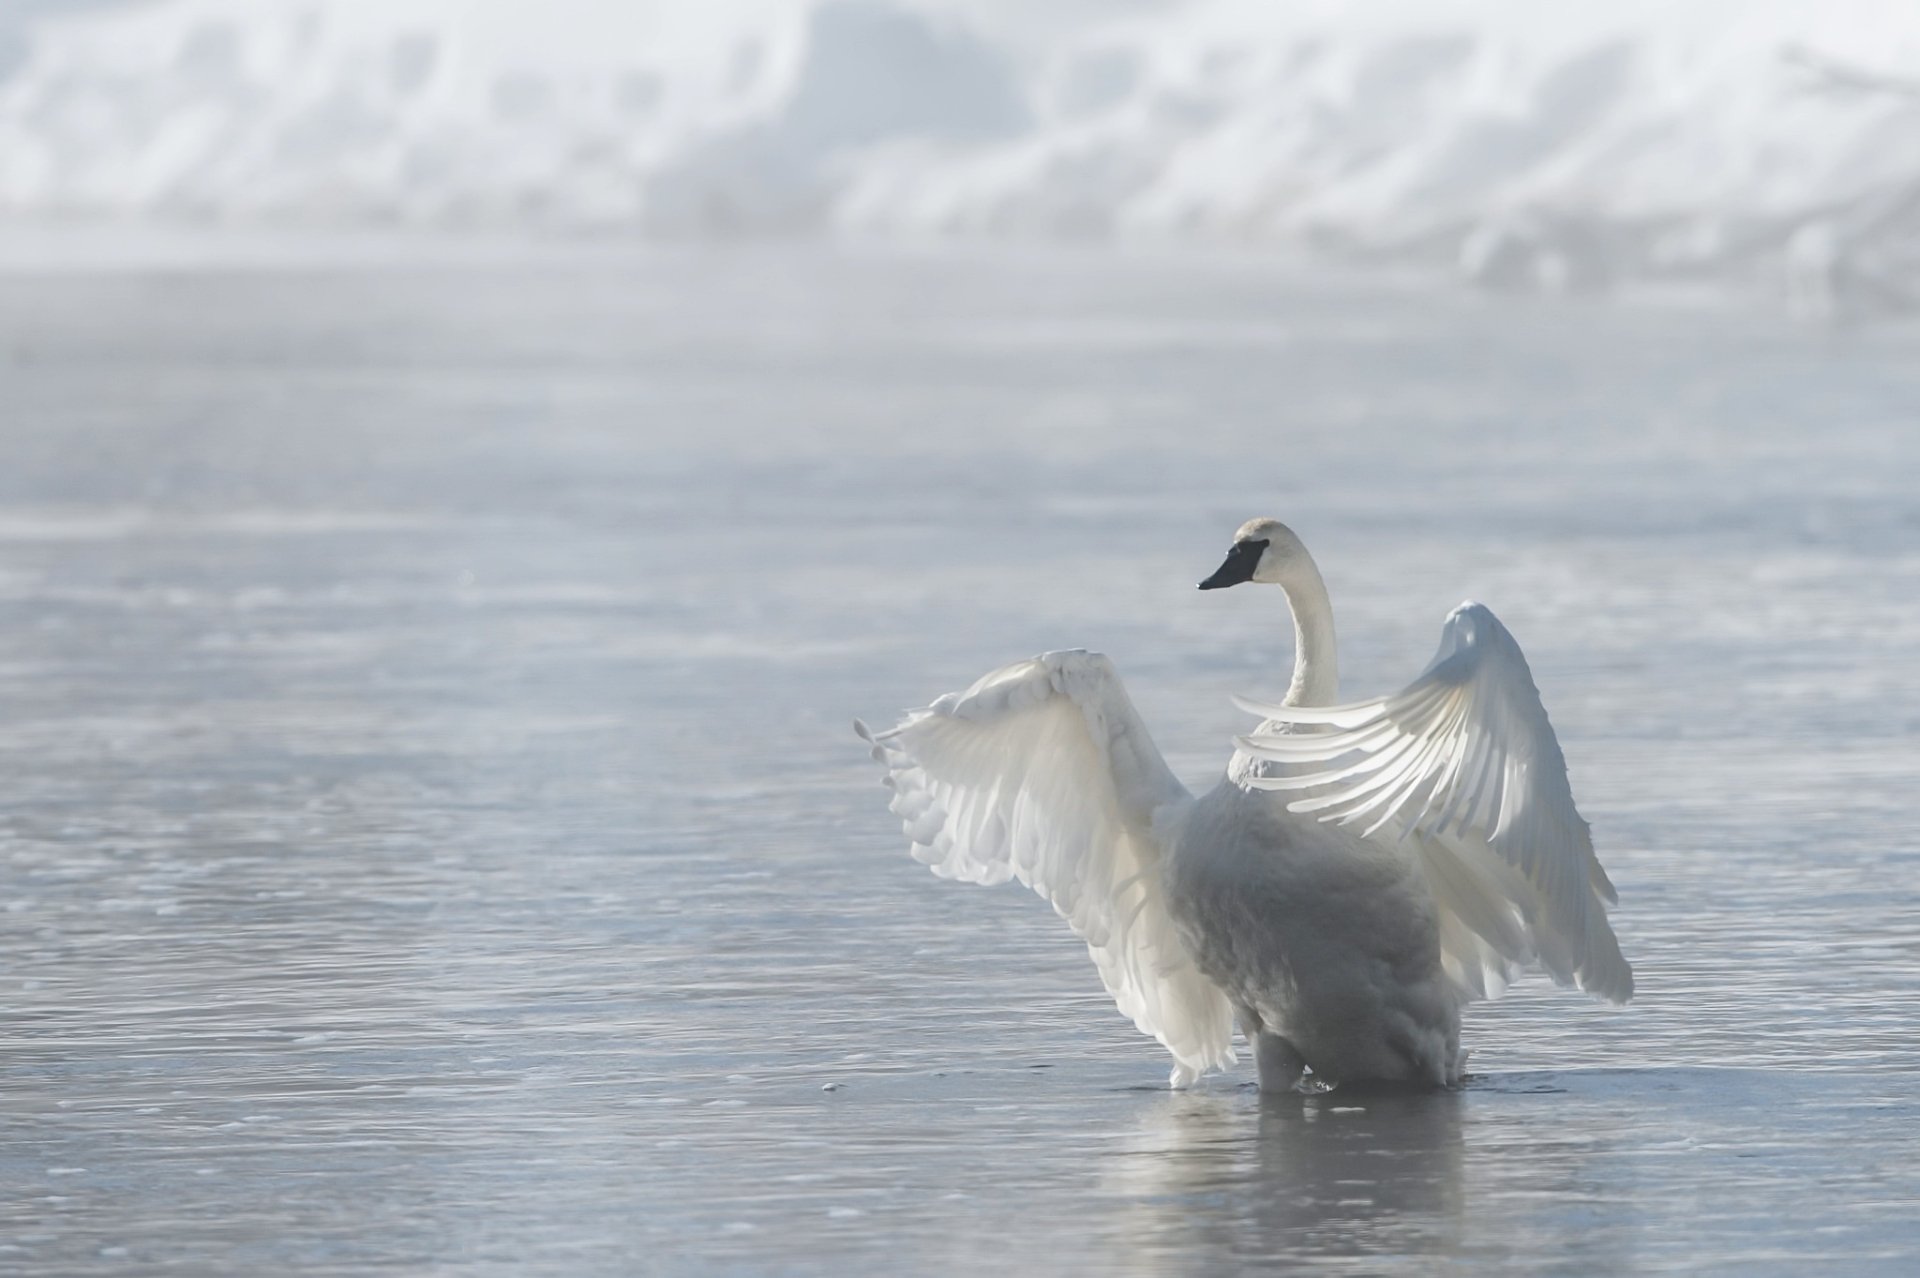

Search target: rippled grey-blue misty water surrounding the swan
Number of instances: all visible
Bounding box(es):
[0,249,1920,1274]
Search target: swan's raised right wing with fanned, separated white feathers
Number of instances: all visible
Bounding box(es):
[1240,603,1634,1004]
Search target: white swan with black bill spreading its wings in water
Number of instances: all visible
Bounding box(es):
[854,520,1634,1090]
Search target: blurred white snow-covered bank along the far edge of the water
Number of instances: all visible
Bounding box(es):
[0,0,1920,317]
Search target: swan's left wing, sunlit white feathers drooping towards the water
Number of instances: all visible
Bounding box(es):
[854,651,1235,1086]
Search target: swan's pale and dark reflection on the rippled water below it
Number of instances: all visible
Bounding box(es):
[1102,1092,1465,1272]
